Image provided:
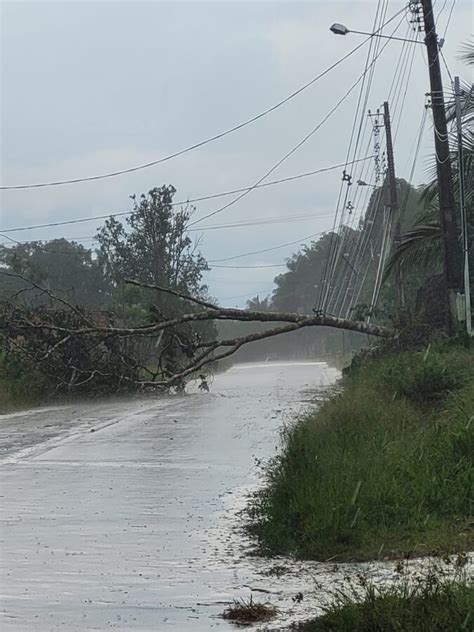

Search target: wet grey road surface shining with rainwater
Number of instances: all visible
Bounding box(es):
[0,363,396,632]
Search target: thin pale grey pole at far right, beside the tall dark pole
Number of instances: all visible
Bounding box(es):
[454,77,472,336]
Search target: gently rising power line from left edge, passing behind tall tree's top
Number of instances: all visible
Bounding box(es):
[0,156,373,233]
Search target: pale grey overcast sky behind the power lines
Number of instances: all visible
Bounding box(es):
[0,0,473,305]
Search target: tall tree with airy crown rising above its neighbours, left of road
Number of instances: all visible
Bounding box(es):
[96,185,215,375]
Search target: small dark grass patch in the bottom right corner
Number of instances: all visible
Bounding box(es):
[294,576,474,632]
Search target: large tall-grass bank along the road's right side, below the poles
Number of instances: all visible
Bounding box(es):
[250,348,474,560]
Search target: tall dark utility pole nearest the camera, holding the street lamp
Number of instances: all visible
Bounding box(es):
[420,0,462,329]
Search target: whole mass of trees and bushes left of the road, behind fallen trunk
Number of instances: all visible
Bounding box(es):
[0,186,215,396]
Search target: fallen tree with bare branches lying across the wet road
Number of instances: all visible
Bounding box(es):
[0,272,395,390]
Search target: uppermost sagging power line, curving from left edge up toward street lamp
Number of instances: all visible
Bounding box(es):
[0,33,386,191]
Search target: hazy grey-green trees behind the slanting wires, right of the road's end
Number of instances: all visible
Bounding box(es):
[271,180,428,336]
